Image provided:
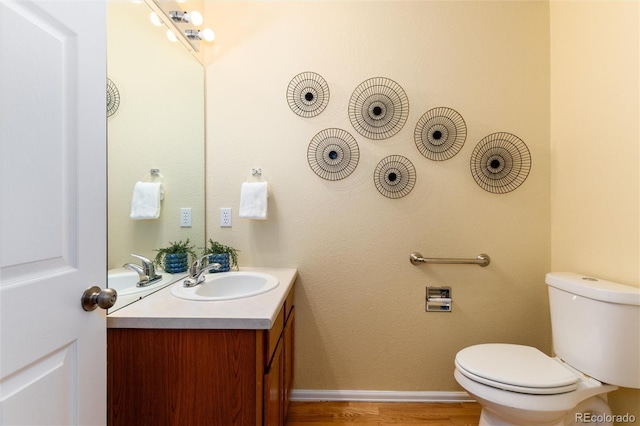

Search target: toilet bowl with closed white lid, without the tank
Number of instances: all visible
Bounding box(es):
[454,344,617,426]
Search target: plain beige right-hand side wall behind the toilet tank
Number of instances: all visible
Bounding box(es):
[551,1,640,418]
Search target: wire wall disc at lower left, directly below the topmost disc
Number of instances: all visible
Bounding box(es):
[307,128,360,180]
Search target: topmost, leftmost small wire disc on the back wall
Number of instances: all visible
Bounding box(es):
[287,72,329,118]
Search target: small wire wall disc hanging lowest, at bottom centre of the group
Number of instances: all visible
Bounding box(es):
[373,155,416,198]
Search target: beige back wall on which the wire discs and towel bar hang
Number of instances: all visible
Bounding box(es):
[205,1,551,391]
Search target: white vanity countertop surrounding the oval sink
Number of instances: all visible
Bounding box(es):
[107,268,298,330]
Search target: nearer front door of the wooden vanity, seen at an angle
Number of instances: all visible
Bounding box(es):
[263,338,284,426]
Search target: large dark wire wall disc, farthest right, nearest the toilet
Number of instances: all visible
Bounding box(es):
[471,132,531,194]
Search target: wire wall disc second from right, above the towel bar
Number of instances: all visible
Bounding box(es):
[413,107,467,161]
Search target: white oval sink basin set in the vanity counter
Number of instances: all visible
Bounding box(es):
[171,271,280,301]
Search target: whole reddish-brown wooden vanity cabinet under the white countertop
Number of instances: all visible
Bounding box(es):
[107,289,295,426]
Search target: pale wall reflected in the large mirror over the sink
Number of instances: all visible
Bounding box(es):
[107,1,205,312]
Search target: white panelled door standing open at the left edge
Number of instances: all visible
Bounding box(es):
[0,0,106,426]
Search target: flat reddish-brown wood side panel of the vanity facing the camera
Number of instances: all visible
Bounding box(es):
[109,328,264,426]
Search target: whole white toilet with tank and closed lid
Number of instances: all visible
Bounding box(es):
[454,272,640,426]
